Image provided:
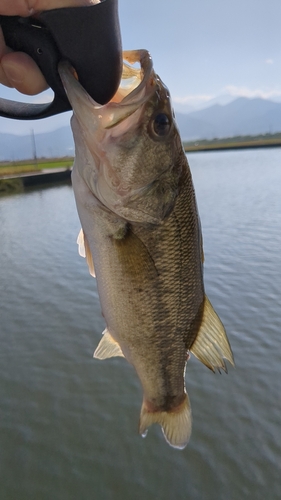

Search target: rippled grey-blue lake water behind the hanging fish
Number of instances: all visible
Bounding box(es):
[0,149,281,500]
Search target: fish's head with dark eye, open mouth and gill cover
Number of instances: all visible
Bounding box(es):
[59,50,182,223]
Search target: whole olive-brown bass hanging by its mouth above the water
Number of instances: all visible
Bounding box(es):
[59,50,234,449]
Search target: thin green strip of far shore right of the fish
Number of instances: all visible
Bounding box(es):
[183,132,281,152]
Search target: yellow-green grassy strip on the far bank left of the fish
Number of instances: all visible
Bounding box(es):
[0,157,73,177]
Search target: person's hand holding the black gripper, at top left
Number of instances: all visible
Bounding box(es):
[0,0,97,95]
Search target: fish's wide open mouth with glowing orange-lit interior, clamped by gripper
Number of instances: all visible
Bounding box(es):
[59,50,156,130]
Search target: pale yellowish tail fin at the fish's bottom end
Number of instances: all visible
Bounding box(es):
[139,394,192,450]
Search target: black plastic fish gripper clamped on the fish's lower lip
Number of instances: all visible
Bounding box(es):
[0,0,122,120]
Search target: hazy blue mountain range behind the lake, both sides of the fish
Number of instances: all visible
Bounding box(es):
[0,97,281,161]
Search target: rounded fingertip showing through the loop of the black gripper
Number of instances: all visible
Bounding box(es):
[1,52,48,95]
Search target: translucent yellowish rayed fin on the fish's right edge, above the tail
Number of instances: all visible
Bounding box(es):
[190,295,234,372]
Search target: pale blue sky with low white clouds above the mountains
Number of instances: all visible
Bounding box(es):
[0,0,281,134]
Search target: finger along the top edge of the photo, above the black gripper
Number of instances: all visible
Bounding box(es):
[0,0,97,16]
